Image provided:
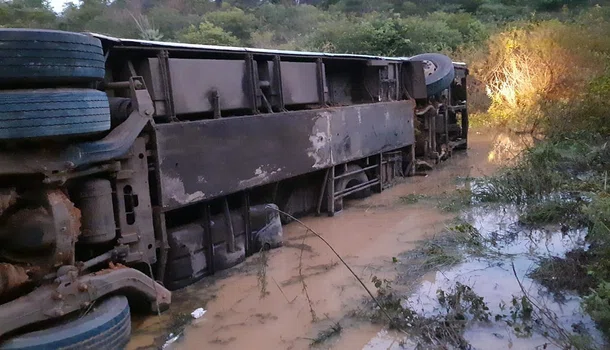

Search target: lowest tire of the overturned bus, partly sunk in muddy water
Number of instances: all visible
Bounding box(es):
[0,296,131,350]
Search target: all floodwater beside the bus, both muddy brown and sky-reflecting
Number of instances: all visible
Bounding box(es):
[128,133,599,349]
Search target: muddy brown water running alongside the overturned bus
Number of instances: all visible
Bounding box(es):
[127,132,552,349]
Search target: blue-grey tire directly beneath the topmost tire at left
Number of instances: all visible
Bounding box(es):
[0,89,110,140]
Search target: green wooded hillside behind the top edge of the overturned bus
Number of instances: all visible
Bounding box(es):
[0,0,604,55]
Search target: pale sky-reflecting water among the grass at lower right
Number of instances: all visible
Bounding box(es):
[363,207,603,350]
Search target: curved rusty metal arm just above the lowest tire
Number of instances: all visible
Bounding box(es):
[0,265,171,335]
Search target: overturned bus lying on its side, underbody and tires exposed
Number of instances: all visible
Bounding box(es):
[0,29,468,349]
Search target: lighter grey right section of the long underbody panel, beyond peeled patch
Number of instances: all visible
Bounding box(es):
[330,101,415,164]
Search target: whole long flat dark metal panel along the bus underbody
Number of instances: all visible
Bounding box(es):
[155,101,414,210]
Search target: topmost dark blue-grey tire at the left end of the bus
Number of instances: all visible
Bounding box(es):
[0,29,105,83]
